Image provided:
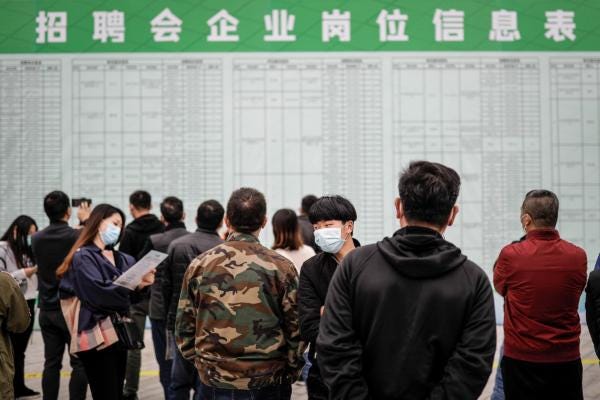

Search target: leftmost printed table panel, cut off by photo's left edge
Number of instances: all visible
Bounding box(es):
[0,59,62,229]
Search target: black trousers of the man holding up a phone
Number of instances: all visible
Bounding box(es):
[39,309,87,400]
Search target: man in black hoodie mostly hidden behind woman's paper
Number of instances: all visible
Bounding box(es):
[119,190,165,400]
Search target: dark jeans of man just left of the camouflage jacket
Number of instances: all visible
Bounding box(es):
[168,335,203,400]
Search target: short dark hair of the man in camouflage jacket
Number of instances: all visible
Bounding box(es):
[227,187,267,233]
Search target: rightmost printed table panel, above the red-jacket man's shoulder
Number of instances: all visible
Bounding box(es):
[550,57,600,266]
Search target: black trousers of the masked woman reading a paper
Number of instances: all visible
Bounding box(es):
[77,342,127,400]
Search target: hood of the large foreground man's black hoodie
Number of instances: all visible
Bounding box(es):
[377,226,467,279]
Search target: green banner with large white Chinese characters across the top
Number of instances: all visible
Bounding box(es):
[0,0,600,53]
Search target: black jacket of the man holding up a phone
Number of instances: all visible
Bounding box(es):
[31,221,81,310]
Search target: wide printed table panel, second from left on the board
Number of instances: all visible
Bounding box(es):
[72,57,224,215]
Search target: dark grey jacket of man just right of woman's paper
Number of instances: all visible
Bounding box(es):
[140,222,189,320]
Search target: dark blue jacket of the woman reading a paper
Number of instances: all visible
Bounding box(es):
[60,244,135,332]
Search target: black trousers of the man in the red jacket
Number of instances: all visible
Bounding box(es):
[500,356,583,400]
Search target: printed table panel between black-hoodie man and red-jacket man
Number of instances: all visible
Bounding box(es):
[392,57,542,271]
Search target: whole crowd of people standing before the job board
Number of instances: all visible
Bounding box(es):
[0,161,600,400]
